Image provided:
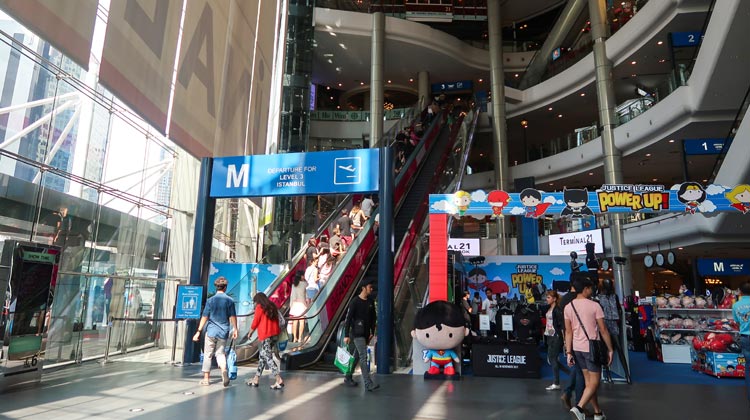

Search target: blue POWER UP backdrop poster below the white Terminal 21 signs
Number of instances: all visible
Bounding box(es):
[464,255,586,300]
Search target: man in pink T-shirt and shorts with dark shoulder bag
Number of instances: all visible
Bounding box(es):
[563,277,613,420]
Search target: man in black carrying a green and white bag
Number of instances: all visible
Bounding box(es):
[344,283,380,391]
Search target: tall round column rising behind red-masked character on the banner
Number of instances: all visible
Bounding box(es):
[487,1,510,255]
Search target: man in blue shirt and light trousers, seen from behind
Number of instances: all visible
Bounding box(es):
[193,277,237,387]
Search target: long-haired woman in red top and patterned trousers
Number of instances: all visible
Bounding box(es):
[245,292,284,389]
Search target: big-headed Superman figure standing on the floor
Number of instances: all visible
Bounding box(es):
[411,301,469,379]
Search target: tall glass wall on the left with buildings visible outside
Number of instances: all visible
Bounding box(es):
[0,12,195,365]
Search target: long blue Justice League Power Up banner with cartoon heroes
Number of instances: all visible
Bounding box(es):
[430,182,750,218]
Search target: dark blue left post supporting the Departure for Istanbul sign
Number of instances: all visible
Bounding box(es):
[182,158,216,364]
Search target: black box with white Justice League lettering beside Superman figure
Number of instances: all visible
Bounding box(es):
[472,343,542,378]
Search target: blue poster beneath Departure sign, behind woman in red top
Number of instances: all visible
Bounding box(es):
[207,262,282,315]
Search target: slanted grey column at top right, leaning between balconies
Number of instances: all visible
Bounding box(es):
[519,0,587,89]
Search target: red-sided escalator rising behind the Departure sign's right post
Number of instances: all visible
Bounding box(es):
[284,107,476,370]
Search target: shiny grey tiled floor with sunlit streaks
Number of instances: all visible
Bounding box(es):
[0,360,750,420]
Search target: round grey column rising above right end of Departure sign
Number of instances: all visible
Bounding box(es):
[370,12,385,147]
